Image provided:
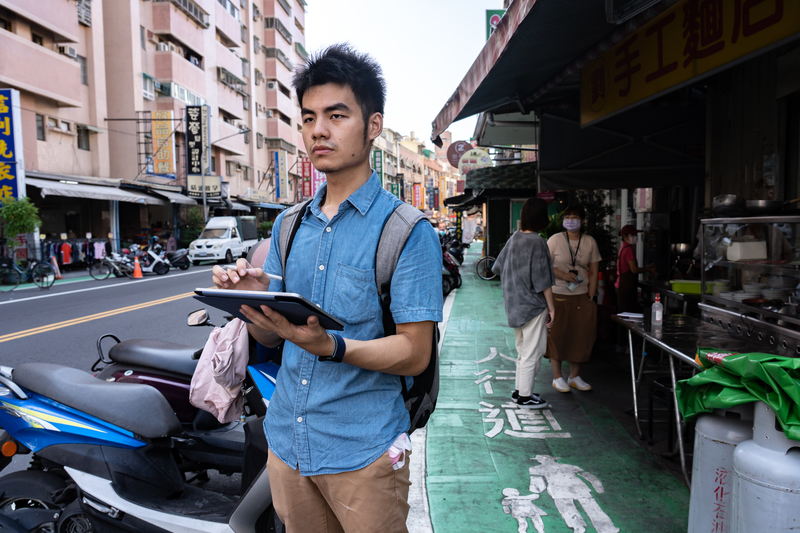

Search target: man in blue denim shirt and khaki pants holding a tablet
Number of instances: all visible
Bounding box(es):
[214,45,442,533]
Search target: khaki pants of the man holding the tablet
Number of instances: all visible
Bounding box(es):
[267,450,411,533]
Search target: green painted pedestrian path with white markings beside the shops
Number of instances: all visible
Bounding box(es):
[426,246,689,533]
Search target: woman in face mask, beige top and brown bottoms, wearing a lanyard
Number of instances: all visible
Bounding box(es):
[545,205,600,392]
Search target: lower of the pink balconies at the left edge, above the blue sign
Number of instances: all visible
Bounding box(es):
[0,30,82,107]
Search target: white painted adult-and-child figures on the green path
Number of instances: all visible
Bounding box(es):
[502,455,619,533]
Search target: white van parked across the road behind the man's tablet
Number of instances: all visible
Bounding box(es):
[189,216,258,264]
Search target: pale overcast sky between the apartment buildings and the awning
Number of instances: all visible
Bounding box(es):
[306,0,503,147]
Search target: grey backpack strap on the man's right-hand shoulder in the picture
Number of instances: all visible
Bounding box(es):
[375,202,426,299]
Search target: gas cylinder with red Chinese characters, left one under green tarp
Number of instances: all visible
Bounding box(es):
[688,403,753,533]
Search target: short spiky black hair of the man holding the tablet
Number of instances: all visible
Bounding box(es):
[292,43,386,139]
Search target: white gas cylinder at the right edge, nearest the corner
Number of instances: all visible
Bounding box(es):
[731,402,800,533]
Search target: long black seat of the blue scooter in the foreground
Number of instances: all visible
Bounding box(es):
[12,363,182,439]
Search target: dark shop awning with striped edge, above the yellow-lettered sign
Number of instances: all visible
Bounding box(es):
[431,0,616,145]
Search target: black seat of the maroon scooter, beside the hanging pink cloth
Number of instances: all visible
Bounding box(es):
[108,339,197,377]
